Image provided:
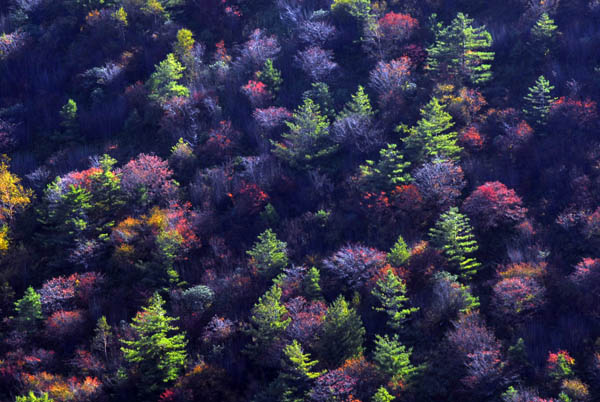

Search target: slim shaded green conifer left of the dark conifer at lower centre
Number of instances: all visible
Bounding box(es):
[245,285,291,363]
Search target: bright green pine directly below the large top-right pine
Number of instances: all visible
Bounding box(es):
[398,97,462,162]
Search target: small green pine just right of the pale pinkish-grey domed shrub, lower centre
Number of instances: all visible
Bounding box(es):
[371,269,419,330]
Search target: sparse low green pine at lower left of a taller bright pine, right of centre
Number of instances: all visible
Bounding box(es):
[359,144,412,191]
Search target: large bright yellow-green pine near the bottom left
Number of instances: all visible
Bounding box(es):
[121,293,187,394]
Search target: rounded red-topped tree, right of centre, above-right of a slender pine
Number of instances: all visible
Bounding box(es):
[463,181,527,231]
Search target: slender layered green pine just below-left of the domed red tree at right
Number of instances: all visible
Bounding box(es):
[429,207,481,279]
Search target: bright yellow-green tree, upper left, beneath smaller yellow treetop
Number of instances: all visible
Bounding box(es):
[147,53,190,103]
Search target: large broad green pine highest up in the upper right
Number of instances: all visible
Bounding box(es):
[426,13,494,85]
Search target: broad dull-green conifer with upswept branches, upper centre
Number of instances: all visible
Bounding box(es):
[271,99,338,169]
